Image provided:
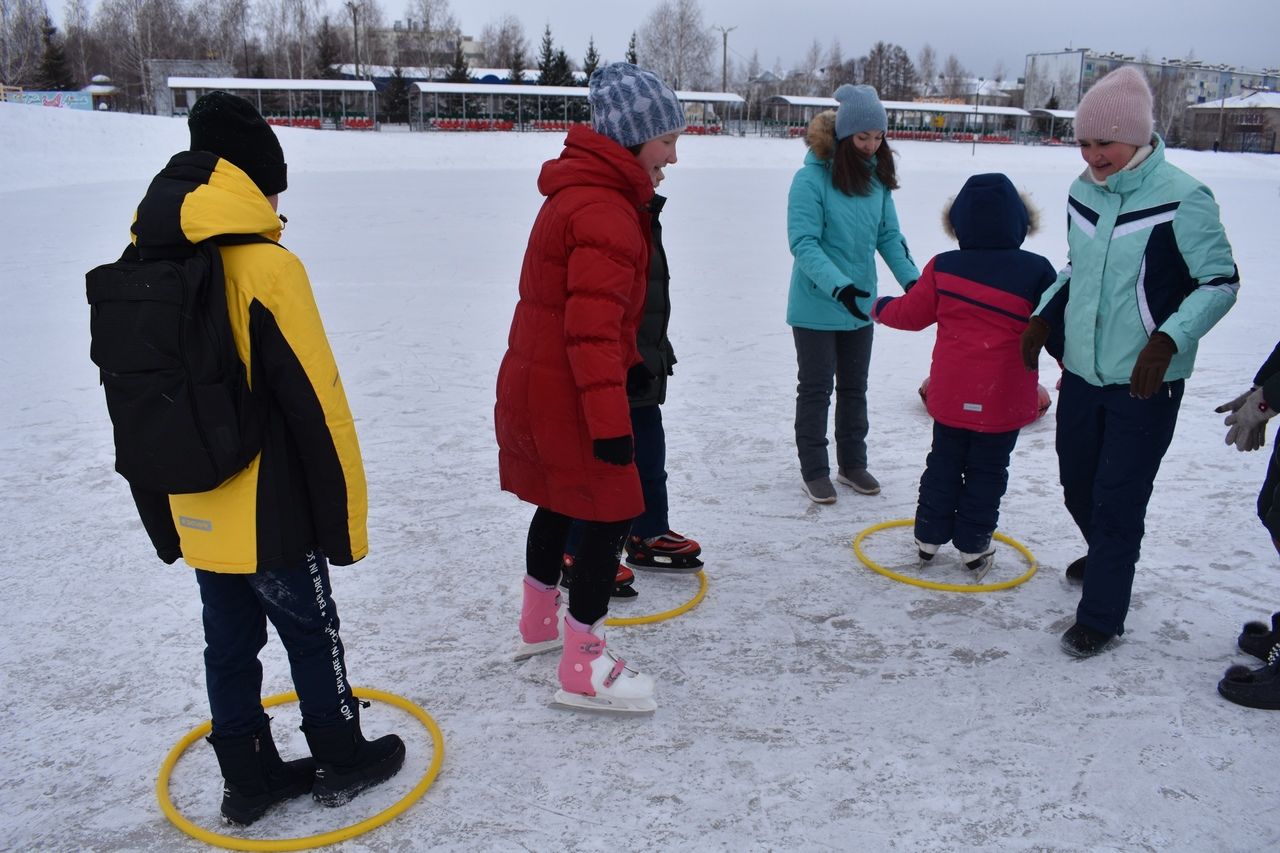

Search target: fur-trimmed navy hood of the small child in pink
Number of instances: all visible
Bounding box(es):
[942,173,1039,248]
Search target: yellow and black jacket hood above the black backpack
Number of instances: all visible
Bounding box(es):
[131,151,280,251]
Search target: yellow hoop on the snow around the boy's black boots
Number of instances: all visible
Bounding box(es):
[156,688,444,850]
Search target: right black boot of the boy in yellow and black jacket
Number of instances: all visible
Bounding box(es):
[302,706,404,806]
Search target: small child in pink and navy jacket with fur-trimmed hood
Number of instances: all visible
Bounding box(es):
[872,174,1057,581]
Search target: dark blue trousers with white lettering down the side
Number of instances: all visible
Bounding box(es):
[196,553,356,738]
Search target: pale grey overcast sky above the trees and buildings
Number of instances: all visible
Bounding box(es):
[437,0,1280,77]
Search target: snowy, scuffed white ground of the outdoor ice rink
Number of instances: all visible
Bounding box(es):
[0,104,1280,850]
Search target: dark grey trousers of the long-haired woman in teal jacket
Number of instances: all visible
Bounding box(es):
[791,325,874,482]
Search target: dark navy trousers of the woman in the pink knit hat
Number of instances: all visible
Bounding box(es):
[1057,371,1185,634]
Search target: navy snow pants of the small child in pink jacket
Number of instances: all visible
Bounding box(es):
[915,421,1019,553]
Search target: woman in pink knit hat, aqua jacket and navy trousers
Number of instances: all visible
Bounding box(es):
[1023,67,1239,657]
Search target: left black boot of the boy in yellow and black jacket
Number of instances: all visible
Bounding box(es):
[207,717,316,826]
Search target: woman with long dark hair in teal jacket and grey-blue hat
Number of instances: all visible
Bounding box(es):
[787,85,920,503]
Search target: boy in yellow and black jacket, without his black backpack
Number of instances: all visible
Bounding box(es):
[120,92,404,824]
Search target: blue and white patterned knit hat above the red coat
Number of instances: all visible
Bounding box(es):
[586,63,685,149]
